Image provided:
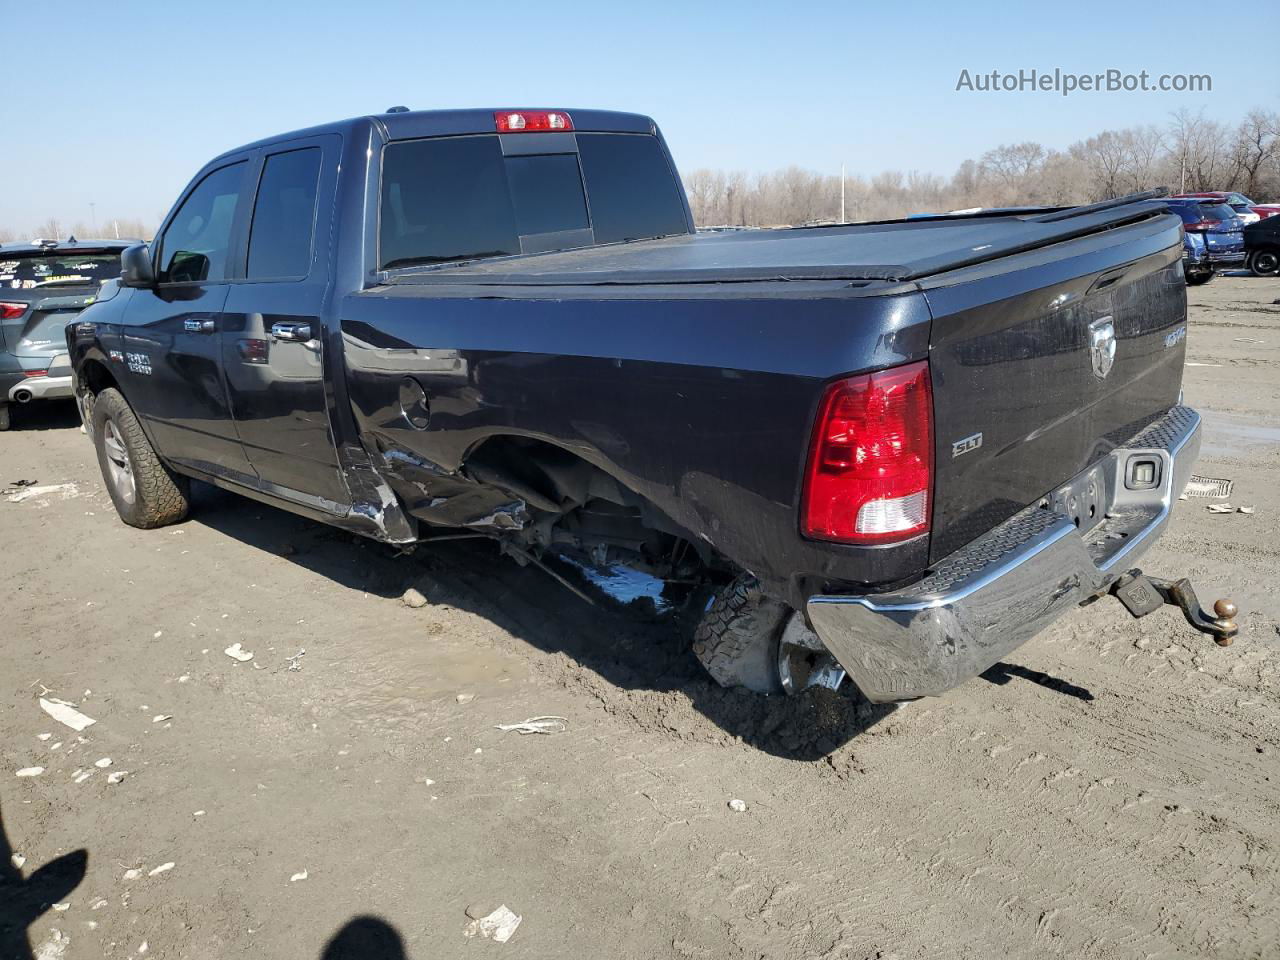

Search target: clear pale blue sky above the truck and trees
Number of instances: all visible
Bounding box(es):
[0,0,1280,233]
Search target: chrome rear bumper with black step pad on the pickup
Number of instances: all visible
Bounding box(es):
[808,406,1201,703]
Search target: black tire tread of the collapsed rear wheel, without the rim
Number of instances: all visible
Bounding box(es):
[694,576,791,694]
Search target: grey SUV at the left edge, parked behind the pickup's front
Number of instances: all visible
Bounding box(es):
[0,238,128,430]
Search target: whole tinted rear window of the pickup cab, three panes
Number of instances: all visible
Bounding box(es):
[379,133,689,269]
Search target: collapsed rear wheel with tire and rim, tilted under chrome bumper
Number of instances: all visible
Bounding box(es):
[694,576,845,694]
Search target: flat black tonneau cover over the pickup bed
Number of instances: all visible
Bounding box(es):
[387,195,1166,287]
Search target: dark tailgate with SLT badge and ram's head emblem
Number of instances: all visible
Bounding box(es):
[922,216,1187,562]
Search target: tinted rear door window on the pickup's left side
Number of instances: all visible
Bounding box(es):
[248,147,320,280]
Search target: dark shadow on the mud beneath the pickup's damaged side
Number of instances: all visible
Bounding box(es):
[192,484,896,762]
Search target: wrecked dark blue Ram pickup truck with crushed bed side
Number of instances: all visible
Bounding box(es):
[68,109,1235,701]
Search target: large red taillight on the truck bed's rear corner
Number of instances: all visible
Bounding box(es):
[800,361,933,543]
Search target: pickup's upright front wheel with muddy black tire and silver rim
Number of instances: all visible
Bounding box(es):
[92,388,191,530]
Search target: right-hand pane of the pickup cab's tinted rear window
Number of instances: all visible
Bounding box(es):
[577,133,689,243]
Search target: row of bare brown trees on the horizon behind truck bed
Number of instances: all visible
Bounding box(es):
[685,109,1280,227]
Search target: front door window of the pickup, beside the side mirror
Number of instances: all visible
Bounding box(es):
[160,160,246,283]
